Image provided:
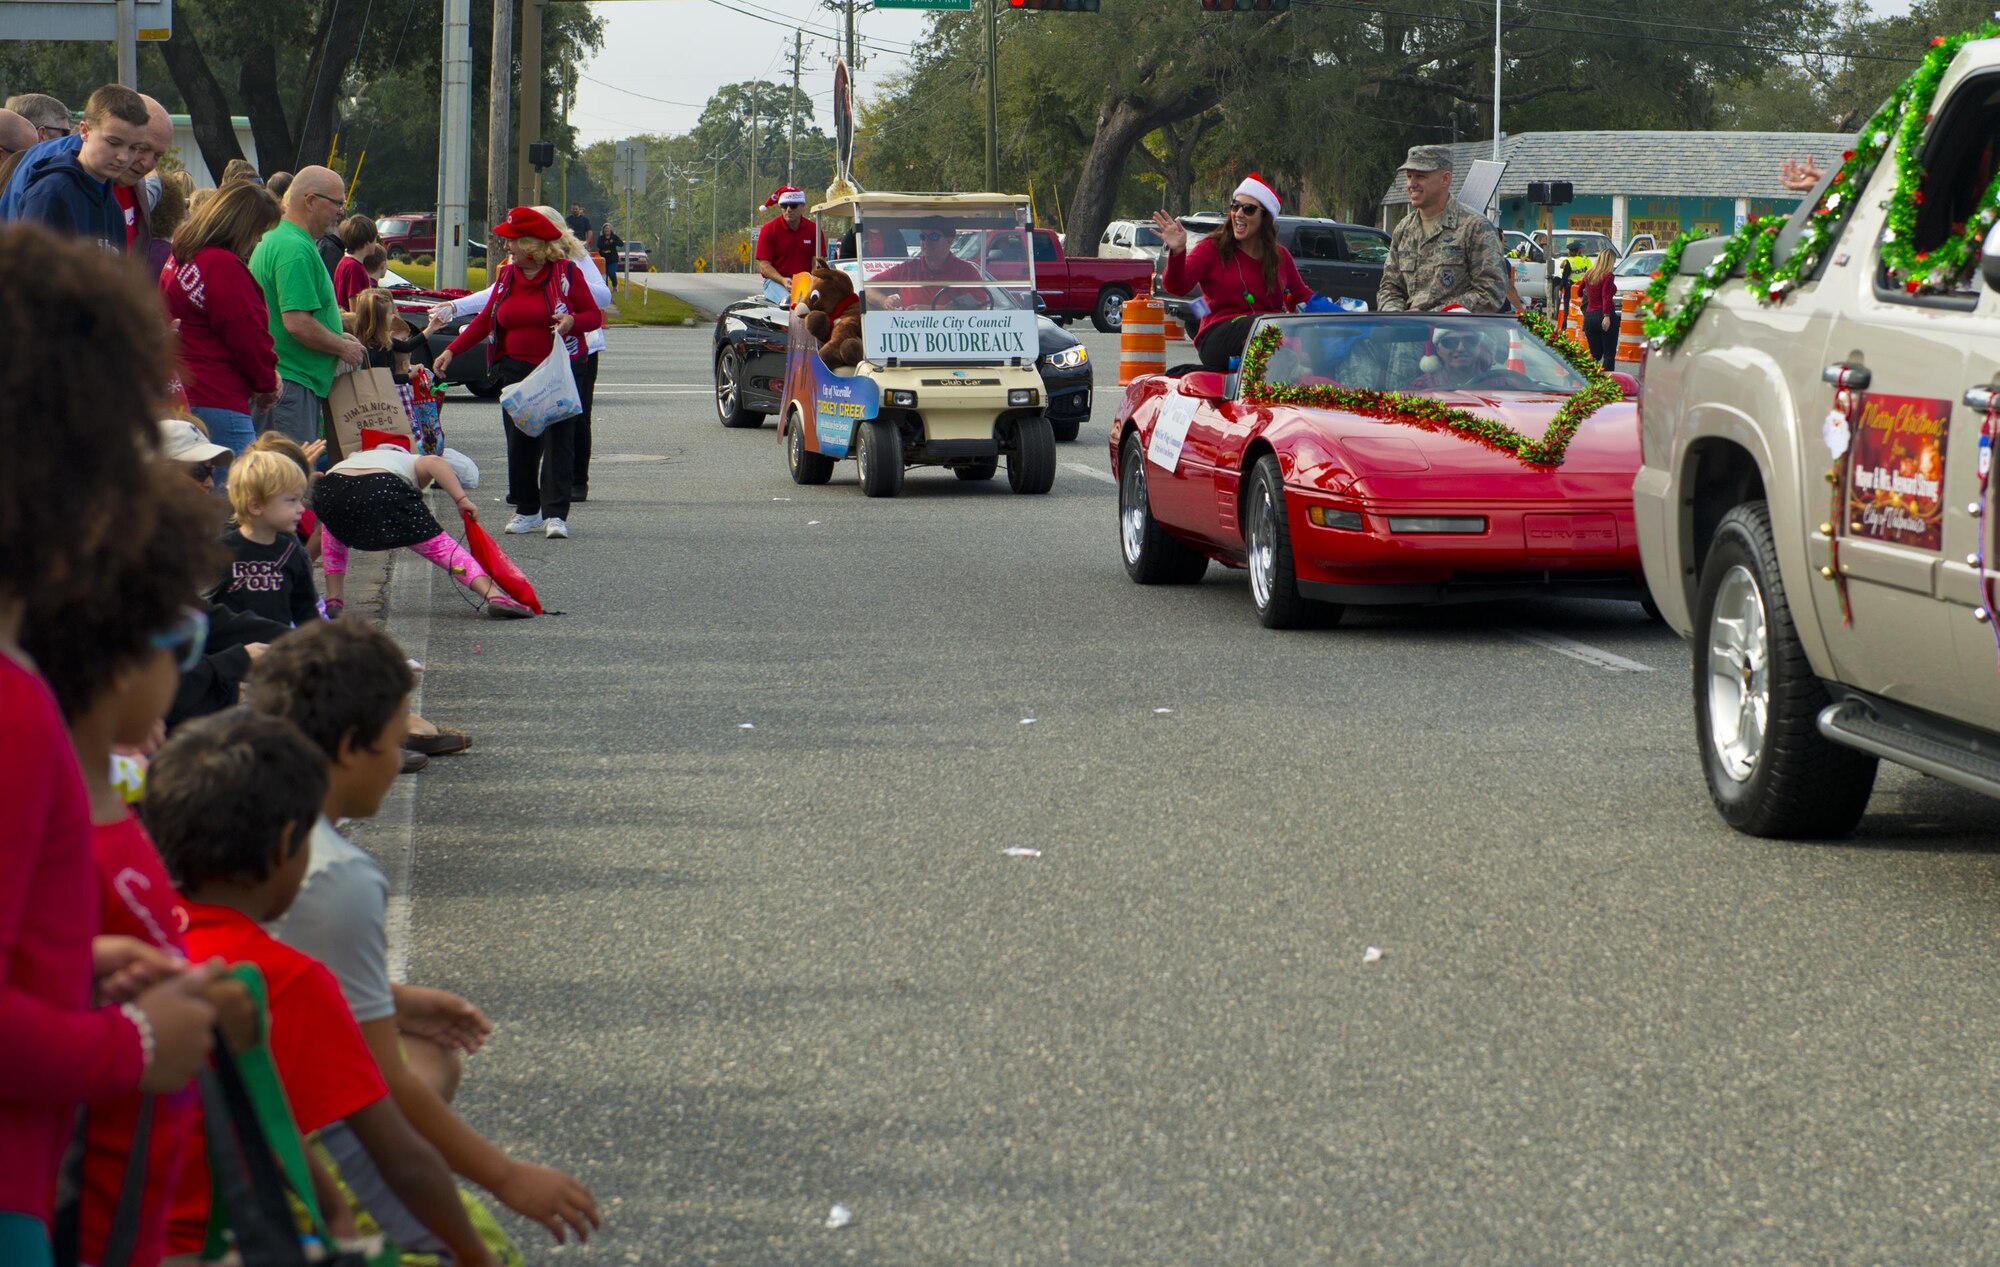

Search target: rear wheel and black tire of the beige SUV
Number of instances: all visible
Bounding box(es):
[1694,502,1876,839]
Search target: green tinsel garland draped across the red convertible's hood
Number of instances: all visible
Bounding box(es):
[1242,312,1624,466]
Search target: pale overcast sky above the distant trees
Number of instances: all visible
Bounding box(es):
[570,0,1910,144]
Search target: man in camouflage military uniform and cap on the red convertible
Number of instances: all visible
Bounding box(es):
[1376,146,1508,312]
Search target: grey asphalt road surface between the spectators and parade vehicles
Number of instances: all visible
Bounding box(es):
[364,319,2000,1267]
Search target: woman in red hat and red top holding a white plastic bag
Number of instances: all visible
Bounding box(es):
[434,206,604,538]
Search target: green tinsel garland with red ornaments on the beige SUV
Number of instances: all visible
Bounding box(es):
[1640,22,2000,352]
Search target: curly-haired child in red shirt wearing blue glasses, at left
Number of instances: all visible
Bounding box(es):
[26,466,256,1267]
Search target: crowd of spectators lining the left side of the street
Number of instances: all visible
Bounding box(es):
[0,84,602,1267]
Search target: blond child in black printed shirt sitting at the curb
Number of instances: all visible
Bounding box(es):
[216,452,320,628]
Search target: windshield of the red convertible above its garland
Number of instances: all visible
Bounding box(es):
[1264,312,1586,394]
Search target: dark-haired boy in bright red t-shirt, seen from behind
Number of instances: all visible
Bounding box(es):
[146,709,494,1267]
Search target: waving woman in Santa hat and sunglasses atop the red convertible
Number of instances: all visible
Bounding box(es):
[1152,172,1312,370]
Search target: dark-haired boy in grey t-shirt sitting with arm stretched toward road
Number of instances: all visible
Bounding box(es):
[248,622,598,1251]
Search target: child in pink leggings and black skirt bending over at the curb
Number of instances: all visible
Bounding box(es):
[312,448,534,618]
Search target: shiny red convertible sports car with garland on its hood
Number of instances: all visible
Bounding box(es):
[1110,312,1648,630]
